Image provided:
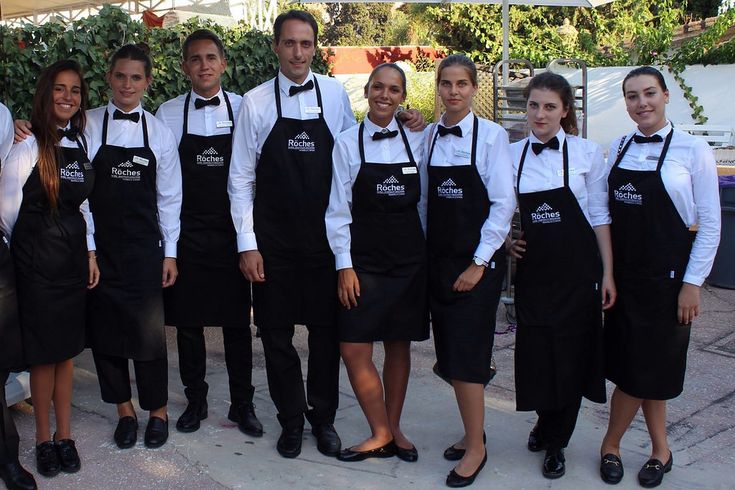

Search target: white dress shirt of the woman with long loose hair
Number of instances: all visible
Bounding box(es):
[0,124,95,250]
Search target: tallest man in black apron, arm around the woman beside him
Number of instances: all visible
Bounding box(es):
[228,10,424,458]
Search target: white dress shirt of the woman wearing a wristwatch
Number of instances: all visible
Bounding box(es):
[424,111,516,262]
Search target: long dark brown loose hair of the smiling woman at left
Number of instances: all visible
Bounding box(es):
[31,60,89,210]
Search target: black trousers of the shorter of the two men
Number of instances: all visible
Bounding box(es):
[176,327,255,406]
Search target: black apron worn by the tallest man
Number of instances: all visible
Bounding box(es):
[253,77,337,328]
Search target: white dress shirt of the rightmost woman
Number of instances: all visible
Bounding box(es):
[607,124,720,286]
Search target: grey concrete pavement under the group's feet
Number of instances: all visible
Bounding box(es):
[7,286,735,490]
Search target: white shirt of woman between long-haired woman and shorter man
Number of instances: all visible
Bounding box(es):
[84,102,181,258]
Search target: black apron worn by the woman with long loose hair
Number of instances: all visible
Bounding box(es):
[10,140,95,365]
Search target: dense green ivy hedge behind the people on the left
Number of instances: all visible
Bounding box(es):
[0,6,328,118]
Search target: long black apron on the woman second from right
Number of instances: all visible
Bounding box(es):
[515,139,605,410]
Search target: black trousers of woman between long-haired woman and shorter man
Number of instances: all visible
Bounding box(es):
[92,351,168,411]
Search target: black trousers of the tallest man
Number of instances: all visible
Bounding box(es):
[260,325,339,429]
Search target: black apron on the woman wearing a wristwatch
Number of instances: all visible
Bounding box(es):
[427,116,507,384]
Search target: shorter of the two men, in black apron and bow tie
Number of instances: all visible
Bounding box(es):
[156,29,263,437]
